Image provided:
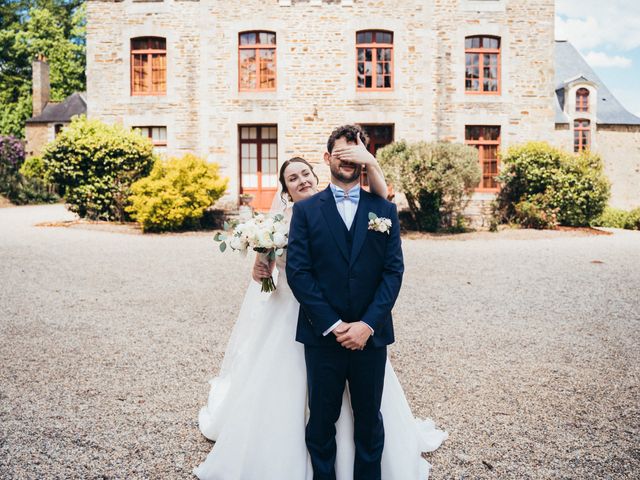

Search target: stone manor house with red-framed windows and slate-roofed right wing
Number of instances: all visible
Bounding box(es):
[86,0,640,219]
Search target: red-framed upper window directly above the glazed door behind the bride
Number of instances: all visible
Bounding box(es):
[238,32,276,91]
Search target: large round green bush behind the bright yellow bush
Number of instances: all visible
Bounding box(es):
[42,117,154,221]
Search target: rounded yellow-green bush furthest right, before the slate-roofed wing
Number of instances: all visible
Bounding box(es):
[497,142,610,228]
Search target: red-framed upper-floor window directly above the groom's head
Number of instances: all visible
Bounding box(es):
[356,30,393,90]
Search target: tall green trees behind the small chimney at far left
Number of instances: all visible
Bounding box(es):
[0,0,86,137]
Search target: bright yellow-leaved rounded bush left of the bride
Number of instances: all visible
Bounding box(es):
[127,154,228,232]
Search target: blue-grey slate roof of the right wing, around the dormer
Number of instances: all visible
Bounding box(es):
[555,40,640,125]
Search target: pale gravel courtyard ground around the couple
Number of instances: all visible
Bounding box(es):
[0,205,640,480]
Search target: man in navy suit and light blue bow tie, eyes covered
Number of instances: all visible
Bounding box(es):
[287,125,404,480]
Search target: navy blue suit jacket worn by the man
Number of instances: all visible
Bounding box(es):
[287,188,404,347]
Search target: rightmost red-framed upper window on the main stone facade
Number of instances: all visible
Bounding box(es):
[464,36,500,95]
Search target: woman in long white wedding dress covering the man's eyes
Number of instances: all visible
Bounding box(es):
[193,143,447,480]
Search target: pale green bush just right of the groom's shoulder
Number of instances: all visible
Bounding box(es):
[377,141,481,231]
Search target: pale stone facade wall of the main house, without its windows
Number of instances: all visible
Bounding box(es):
[87,0,554,214]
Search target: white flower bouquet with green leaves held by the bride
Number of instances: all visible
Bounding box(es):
[214,213,289,292]
